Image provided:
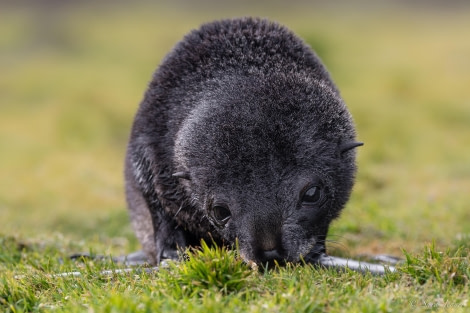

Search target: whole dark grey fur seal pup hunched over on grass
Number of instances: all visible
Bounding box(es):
[125,18,362,264]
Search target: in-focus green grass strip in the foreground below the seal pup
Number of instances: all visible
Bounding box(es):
[0,237,470,312]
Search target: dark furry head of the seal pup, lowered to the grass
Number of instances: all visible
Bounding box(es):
[174,73,360,264]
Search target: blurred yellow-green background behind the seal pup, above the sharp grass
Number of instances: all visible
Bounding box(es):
[0,0,470,254]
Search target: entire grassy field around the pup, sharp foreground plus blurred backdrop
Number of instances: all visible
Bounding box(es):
[0,4,470,312]
